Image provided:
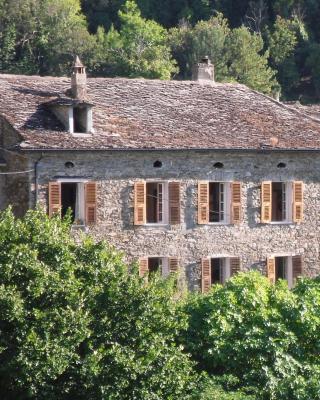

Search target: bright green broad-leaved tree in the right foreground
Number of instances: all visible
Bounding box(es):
[184,272,320,400]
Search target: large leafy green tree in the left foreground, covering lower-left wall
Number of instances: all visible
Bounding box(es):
[0,210,196,400]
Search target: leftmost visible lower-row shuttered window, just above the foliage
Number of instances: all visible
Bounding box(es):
[139,257,179,277]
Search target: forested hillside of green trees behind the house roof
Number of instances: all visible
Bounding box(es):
[0,0,320,102]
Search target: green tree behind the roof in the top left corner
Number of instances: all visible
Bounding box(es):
[0,0,94,75]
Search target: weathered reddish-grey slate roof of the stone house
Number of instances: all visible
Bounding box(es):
[0,75,320,150]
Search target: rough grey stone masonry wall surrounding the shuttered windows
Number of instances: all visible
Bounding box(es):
[25,151,320,288]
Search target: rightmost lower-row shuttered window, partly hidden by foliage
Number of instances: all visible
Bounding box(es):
[267,255,303,288]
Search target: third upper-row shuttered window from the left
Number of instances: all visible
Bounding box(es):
[198,181,242,224]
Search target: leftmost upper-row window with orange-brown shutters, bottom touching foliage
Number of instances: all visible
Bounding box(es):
[49,181,97,225]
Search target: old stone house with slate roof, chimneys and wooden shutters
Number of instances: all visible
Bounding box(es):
[0,59,320,291]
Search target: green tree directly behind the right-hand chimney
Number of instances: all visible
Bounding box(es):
[170,14,277,94]
